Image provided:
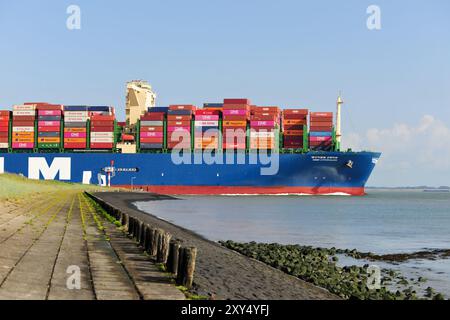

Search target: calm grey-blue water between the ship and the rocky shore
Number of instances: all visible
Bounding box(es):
[137,190,450,297]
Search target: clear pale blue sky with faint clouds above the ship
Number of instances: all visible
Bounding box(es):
[0,0,450,185]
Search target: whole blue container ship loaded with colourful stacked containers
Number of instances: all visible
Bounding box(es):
[0,81,381,195]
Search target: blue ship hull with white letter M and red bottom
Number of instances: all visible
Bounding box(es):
[0,152,381,195]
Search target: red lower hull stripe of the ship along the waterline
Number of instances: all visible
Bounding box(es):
[114,185,365,196]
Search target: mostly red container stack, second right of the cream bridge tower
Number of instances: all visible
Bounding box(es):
[167,105,196,149]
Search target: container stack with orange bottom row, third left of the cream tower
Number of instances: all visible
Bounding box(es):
[36,104,63,149]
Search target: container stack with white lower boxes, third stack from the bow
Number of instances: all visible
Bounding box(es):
[250,106,280,150]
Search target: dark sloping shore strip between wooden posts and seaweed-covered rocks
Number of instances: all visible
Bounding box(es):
[95,192,340,300]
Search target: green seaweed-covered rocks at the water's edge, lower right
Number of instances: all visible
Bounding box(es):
[220,241,443,300]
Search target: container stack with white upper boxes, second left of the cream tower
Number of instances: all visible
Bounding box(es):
[64,106,89,149]
